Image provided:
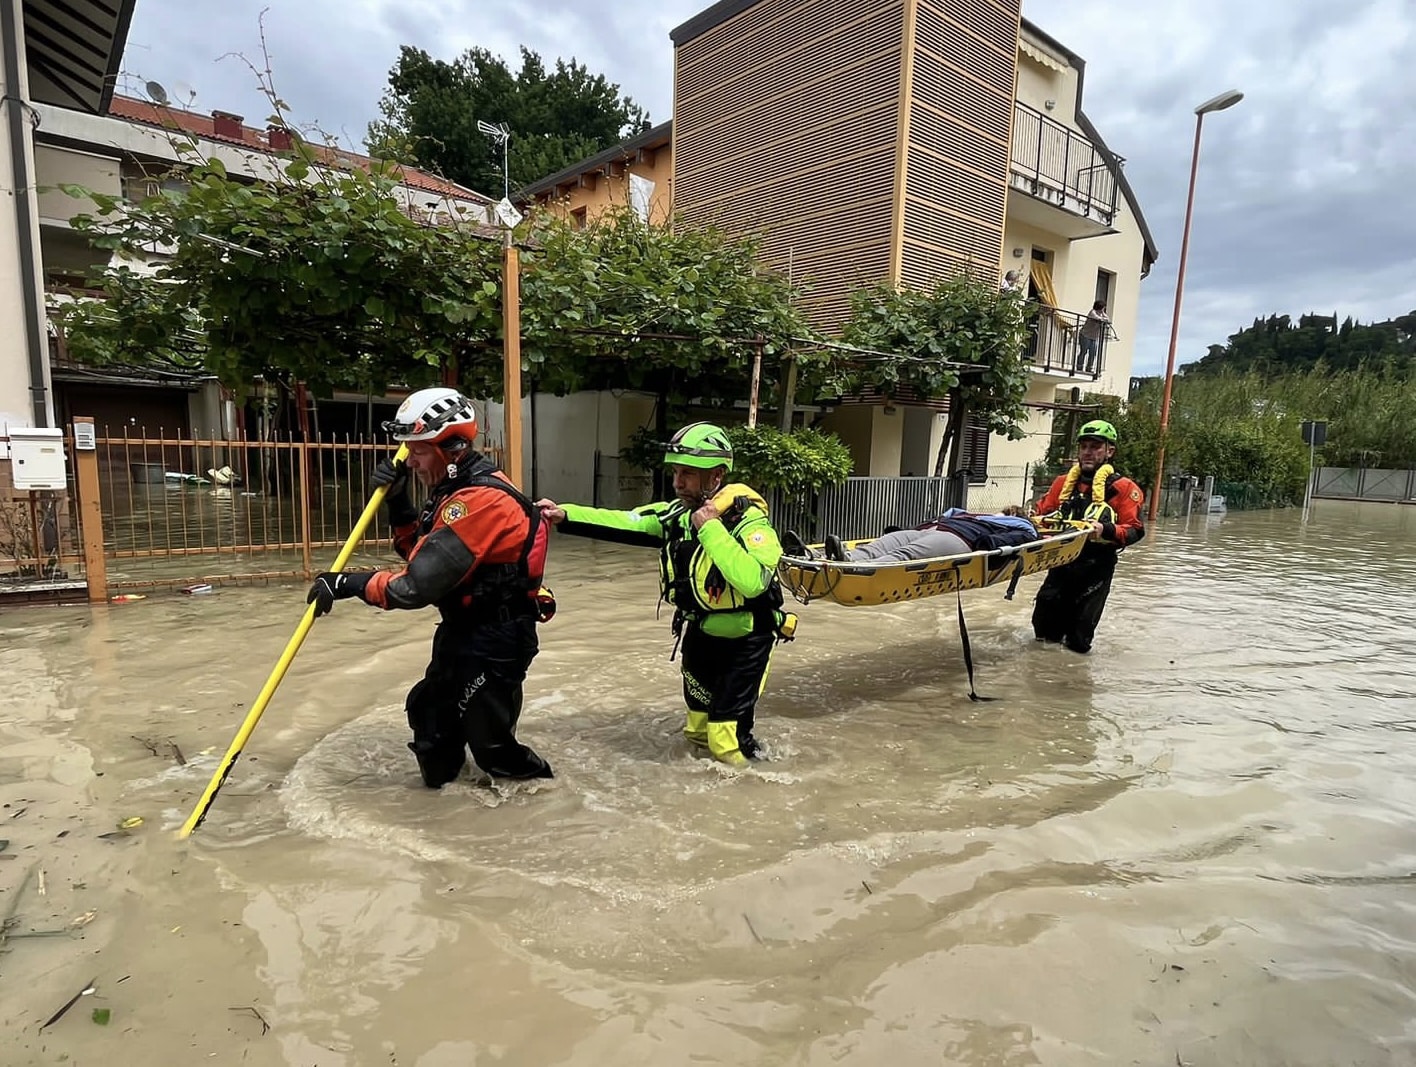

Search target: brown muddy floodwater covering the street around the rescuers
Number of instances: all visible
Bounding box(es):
[0,504,1416,1067]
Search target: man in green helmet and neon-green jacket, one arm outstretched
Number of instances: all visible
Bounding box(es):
[537,422,796,767]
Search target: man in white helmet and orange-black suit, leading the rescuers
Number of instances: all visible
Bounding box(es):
[306,388,554,790]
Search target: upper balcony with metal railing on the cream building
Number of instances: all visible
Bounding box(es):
[1008,102,1121,238]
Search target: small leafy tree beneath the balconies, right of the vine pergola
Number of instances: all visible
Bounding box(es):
[838,275,1031,473]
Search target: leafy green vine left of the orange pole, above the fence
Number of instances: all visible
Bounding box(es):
[67,146,500,392]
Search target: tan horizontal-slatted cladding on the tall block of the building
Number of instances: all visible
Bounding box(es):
[673,0,1020,330]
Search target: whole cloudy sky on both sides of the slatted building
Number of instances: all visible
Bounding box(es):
[123,0,1416,374]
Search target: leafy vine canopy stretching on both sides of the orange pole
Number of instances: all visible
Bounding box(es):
[65,154,807,403]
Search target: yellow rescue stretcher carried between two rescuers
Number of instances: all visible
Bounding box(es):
[777,528,1090,607]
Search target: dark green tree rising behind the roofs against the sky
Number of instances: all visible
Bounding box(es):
[367,45,649,198]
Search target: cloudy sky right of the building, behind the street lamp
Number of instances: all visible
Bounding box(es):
[1027,0,1416,374]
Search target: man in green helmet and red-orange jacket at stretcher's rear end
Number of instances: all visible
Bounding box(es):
[1032,419,1146,654]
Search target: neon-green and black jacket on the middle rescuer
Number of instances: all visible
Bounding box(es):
[556,500,782,637]
